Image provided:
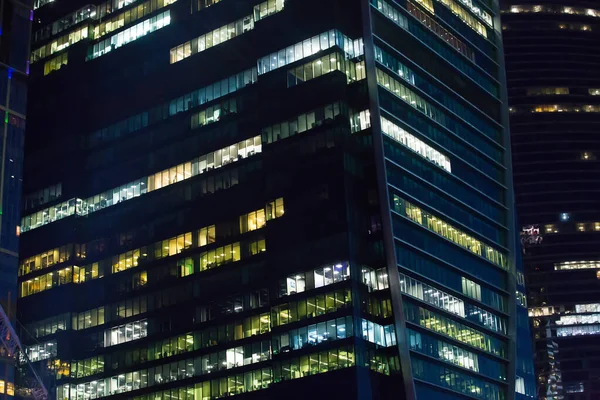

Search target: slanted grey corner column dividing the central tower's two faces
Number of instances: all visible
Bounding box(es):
[362,0,416,400]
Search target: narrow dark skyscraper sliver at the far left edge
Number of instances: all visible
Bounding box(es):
[0,0,31,394]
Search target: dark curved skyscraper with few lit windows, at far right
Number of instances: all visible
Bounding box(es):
[502,1,600,399]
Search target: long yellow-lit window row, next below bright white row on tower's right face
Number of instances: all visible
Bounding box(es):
[393,195,508,270]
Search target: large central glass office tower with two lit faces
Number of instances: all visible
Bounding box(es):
[19,0,517,400]
